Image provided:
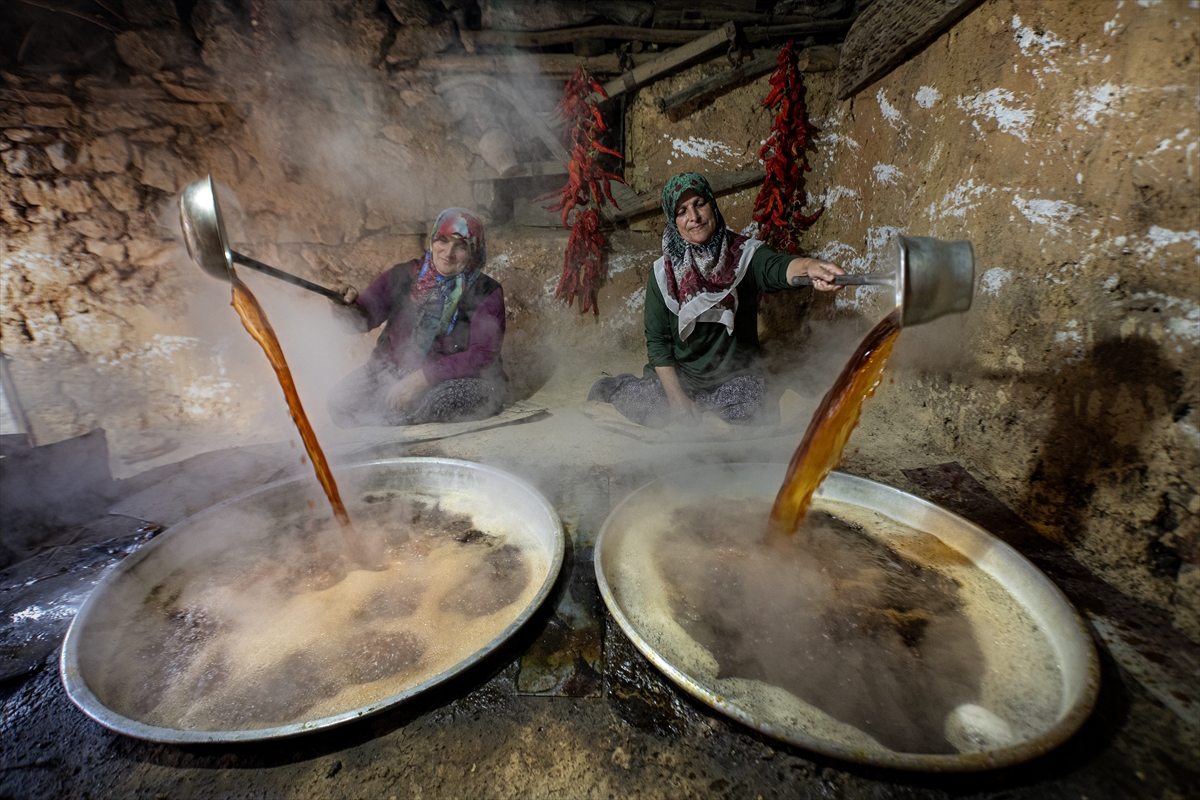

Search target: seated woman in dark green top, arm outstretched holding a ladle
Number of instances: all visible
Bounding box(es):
[588,173,844,428]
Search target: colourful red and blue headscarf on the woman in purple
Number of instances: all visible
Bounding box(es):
[409,209,487,356]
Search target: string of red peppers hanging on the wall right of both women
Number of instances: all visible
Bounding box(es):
[754,41,824,254]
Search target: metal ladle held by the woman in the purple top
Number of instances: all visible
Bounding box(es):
[179,175,346,305]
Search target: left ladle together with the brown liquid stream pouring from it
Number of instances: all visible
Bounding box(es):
[179,175,372,566]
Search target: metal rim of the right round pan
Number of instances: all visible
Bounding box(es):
[594,463,1100,772]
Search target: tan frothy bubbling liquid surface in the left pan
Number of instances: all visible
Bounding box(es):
[90,492,548,730]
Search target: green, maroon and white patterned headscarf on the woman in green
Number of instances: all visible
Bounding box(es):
[662,173,746,338]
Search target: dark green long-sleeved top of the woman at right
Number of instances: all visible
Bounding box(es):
[644,247,796,392]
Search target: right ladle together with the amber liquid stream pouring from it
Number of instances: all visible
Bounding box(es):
[767,235,974,541]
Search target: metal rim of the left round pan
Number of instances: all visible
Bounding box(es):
[60,457,566,744]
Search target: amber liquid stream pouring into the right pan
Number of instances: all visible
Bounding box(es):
[767,308,900,541]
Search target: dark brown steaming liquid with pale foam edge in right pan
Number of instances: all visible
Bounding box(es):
[606,491,1062,754]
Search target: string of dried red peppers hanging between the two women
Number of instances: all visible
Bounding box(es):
[539,67,625,314]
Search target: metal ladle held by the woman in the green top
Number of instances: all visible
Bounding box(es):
[792,235,974,327]
